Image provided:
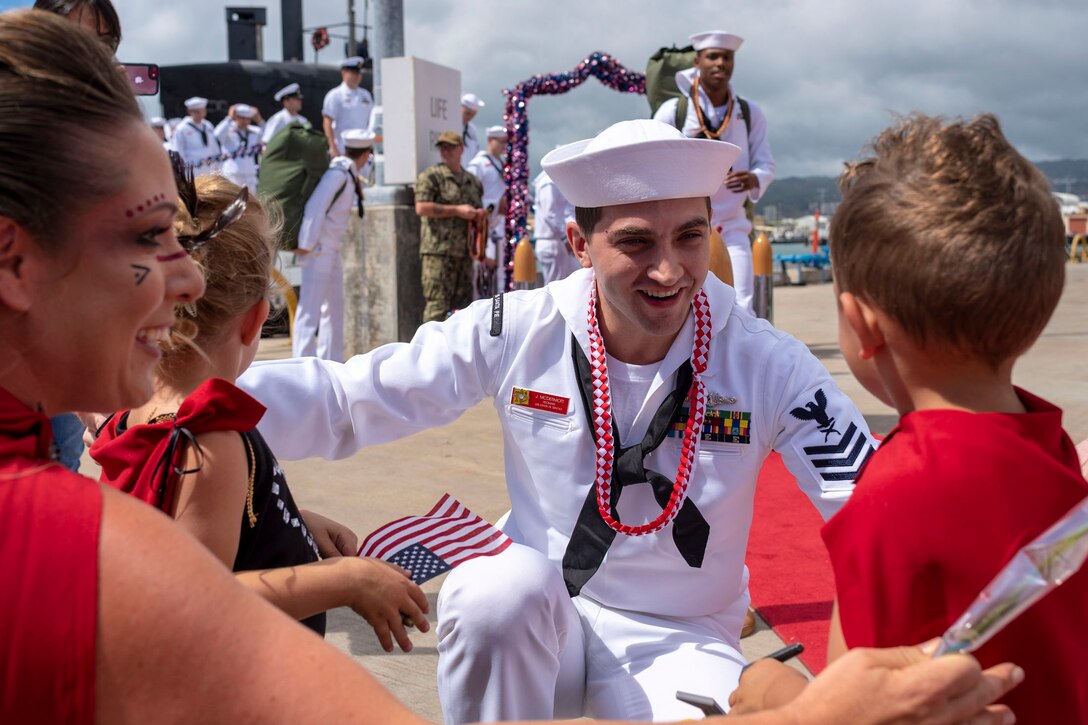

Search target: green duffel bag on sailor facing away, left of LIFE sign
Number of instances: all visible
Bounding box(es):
[257,121,329,249]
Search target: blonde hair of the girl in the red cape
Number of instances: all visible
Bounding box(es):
[162,174,275,363]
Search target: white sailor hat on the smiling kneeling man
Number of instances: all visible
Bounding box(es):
[541,120,741,208]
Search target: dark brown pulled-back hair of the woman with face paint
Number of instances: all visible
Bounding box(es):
[0,10,146,249]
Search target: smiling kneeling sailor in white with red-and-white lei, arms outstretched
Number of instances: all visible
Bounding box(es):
[233,120,875,723]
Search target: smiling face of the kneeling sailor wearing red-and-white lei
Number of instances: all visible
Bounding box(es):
[568,197,710,365]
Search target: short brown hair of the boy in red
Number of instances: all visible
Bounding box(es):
[830,114,1065,367]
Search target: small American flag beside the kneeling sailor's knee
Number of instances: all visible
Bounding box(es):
[359,493,510,583]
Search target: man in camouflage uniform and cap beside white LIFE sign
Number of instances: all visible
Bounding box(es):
[416,131,487,322]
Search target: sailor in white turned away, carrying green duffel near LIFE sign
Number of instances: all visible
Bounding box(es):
[290,128,374,363]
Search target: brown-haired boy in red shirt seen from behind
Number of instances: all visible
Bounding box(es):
[734,114,1088,723]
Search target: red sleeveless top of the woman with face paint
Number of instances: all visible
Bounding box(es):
[0,389,102,724]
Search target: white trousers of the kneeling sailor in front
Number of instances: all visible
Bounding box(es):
[437,544,744,725]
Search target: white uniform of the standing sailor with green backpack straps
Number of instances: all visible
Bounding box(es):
[654,69,775,310]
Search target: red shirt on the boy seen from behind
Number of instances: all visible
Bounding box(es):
[823,391,1088,725]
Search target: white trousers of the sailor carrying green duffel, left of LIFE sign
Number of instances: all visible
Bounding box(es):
[290,249,344,363]
